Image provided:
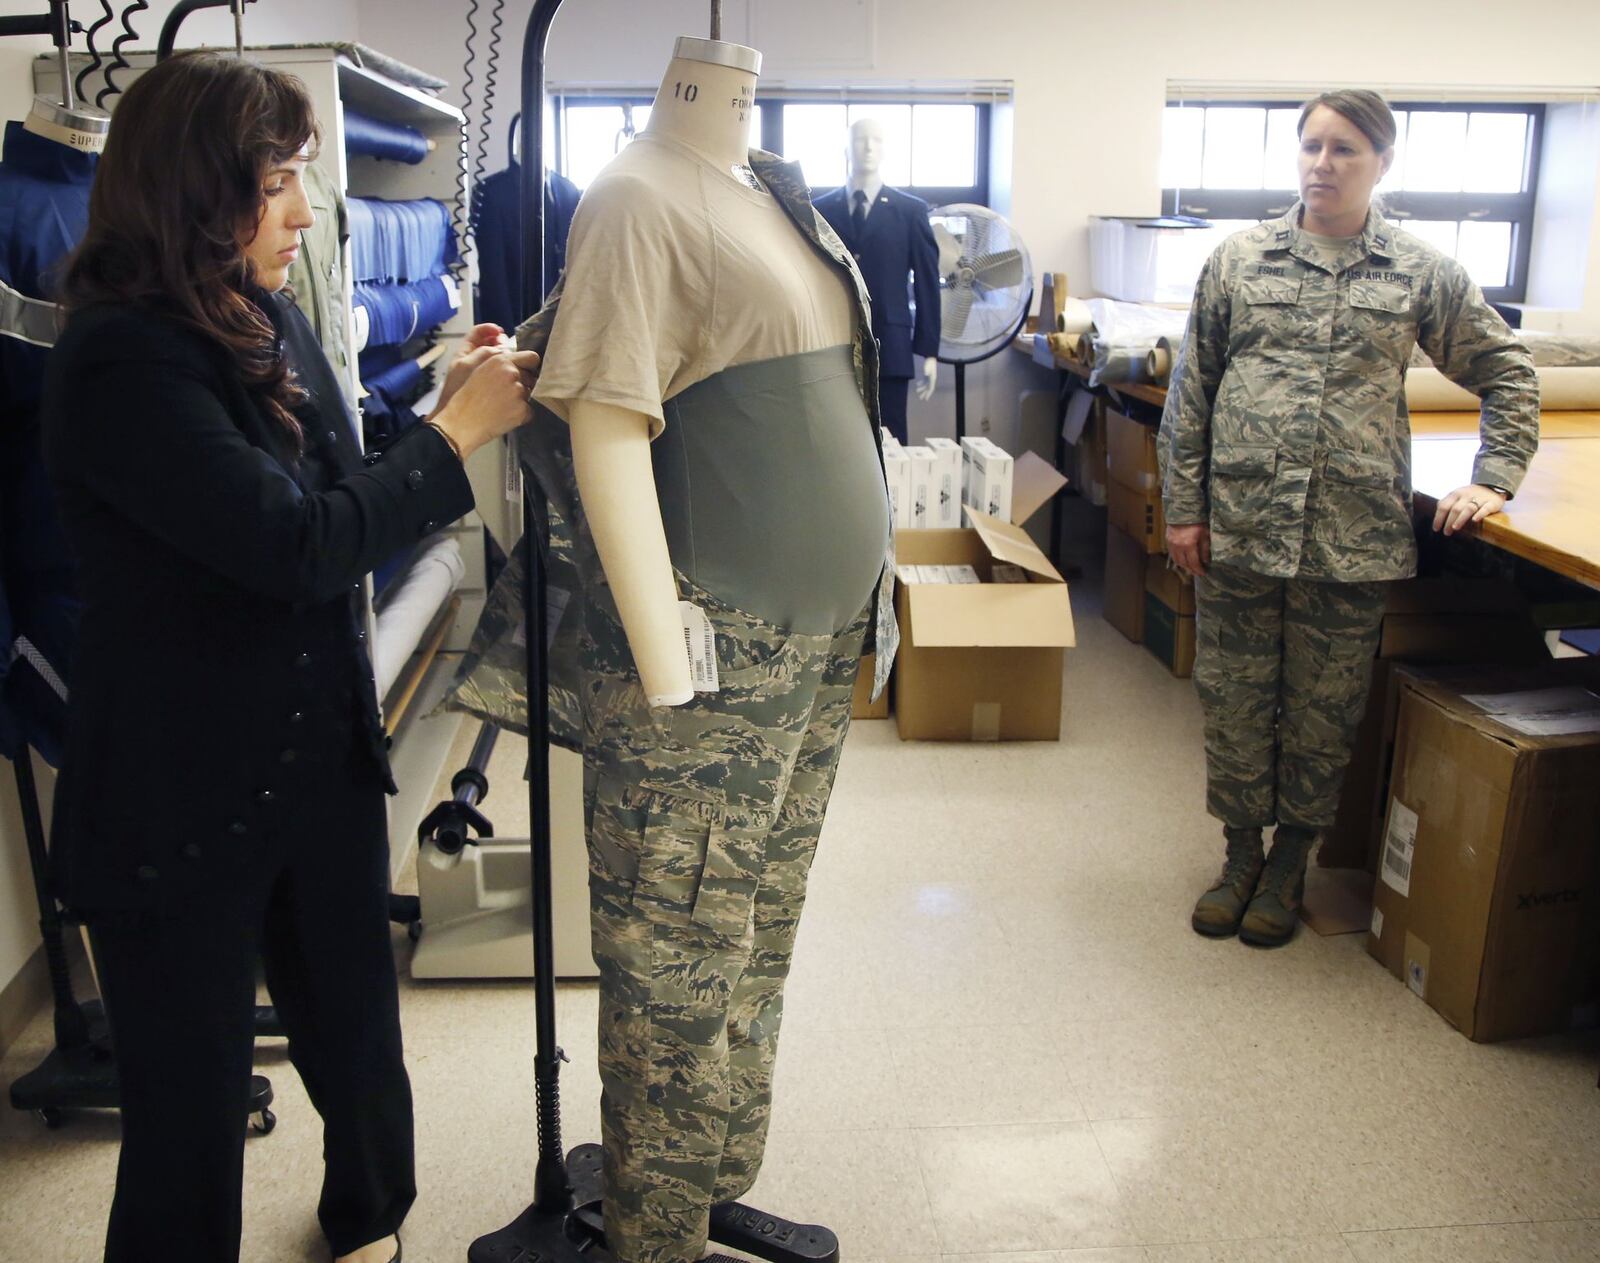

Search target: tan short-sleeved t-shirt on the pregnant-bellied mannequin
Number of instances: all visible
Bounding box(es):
[534,131,856,437]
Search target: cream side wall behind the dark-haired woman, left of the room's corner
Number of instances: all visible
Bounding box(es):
[0,0,363,1018]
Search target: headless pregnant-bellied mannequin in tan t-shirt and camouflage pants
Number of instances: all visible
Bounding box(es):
[536,38,890,1263]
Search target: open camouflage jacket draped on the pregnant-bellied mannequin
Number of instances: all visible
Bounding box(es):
[446,149,899,749]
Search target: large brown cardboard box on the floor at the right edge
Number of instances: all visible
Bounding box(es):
[1366,660,1600,1042]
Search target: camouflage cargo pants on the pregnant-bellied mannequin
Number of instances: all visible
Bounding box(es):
[584,576,869,1263]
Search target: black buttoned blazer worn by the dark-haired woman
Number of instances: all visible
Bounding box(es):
[42,295,472,911]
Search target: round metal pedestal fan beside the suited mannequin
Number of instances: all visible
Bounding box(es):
[928,202,1034,439]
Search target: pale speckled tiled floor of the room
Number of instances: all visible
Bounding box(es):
[0,586,1600,1263]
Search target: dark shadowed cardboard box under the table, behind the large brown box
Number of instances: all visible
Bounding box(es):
[1317,578,1549,872]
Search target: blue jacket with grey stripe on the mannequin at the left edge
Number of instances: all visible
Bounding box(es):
[0,122,99,765]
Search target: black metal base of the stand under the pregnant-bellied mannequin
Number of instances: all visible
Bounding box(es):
[467,1145,838,1263]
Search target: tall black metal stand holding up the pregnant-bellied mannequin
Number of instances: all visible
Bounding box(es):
[467,0,838,1263]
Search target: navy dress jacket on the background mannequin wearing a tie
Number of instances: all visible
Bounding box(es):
[816,186,939,378]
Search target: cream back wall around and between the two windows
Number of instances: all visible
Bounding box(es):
[360,0,1600,442]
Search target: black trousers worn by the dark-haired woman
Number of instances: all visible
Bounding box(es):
[88,760,416,1263]
